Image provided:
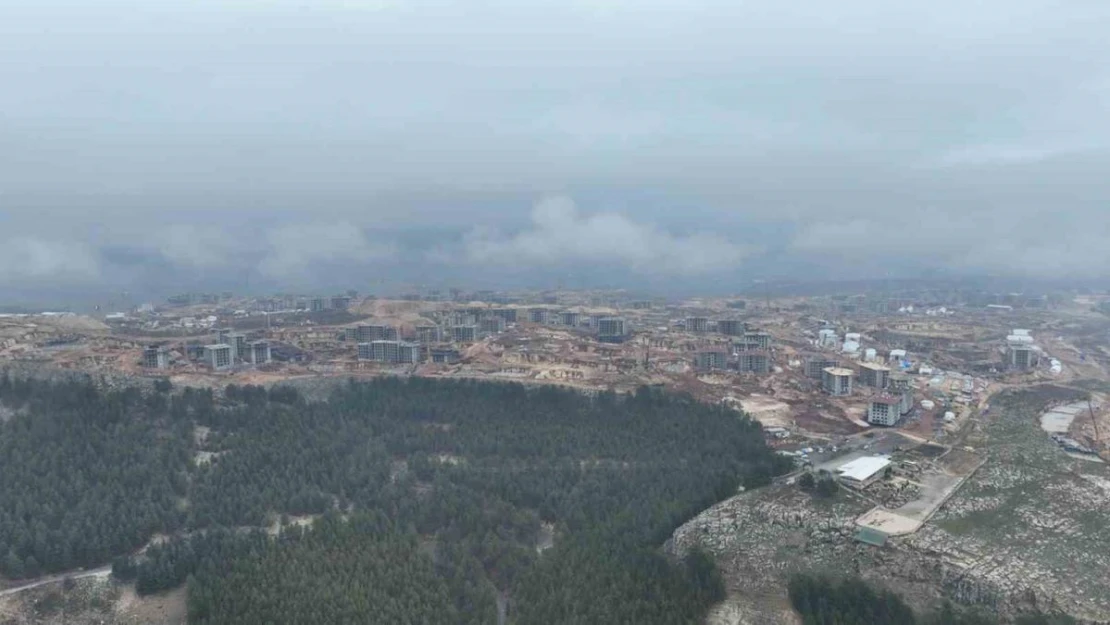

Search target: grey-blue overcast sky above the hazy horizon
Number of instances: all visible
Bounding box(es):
[0,0,1110,300]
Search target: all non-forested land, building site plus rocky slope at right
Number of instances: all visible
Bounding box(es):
[0,292,1110,624]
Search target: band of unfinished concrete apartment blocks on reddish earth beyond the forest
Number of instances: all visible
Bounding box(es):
[0,292,1110,456]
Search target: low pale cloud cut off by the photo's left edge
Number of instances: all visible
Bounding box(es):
[0,238,100,284]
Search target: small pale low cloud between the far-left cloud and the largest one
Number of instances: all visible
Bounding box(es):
[259,222,397,279]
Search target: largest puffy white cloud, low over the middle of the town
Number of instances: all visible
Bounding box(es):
[455,198,753,274]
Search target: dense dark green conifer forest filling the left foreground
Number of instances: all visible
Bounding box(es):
[0,379,787,625]
